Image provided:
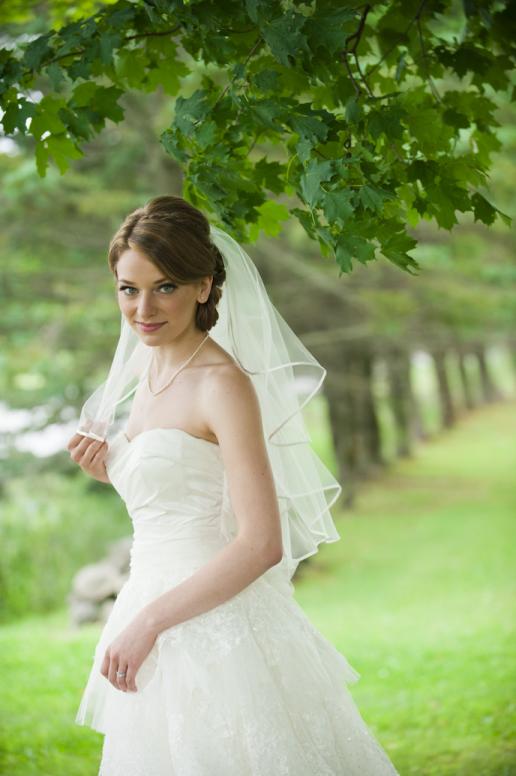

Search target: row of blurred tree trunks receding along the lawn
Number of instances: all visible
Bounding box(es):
[324,341,502,507]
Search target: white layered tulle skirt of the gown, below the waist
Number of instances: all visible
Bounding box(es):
[75,567,397,776]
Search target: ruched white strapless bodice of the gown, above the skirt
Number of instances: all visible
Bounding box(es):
[106,428,234,574]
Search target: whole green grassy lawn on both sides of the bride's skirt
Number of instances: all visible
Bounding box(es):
[0,403,516,776]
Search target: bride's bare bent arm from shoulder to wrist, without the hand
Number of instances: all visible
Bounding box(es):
[137,367,283,636]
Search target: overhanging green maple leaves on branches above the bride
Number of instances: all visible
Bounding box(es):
[0,0,514,273]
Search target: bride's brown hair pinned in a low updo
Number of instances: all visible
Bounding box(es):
[108,195,226,331]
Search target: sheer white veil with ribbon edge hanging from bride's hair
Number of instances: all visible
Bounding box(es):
[77,226,342,579]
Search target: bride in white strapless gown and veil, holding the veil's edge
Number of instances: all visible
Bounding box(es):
[68,196,397,776]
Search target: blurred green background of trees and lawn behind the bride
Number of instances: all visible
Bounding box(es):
[0,1,516,776]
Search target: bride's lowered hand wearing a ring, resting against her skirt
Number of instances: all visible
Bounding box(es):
[100,617,157,692]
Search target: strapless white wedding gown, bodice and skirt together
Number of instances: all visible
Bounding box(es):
[75,428,397,776]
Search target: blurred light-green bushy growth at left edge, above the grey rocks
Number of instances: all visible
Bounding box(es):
[0,472,131,622]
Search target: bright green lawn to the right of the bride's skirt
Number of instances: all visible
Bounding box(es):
[296,403,516,776]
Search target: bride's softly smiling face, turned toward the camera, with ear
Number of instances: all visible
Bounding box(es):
[116,242,212,345]
